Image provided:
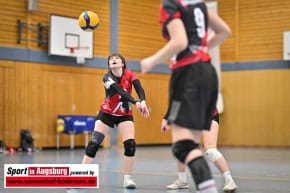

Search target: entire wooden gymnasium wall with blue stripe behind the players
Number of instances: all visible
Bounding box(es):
[0,0,290,147]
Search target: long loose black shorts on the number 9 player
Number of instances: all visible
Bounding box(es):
[168,62,218,130]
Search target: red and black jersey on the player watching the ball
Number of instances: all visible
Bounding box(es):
[101,69,138,116]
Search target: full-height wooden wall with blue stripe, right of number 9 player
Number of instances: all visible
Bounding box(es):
[218,0,290,146]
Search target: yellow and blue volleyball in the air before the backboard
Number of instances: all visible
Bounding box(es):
[78,11,100,32]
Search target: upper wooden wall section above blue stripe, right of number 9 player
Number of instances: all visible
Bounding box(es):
[218,0,290,62]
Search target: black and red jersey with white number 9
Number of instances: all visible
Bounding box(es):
[160,0,210,70]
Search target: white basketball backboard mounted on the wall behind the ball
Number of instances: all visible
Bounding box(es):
[48,15,94,63]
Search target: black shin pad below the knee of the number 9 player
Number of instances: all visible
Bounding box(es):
[187,156,213,189]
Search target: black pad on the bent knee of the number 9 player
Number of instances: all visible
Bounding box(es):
[172,139,198,163]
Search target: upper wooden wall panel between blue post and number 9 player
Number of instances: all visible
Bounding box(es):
[118,0,164,60]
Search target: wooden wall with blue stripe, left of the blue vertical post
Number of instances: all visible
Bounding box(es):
[0,0,111,147]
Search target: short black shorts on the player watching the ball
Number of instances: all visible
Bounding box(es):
[97,111,133,128]
